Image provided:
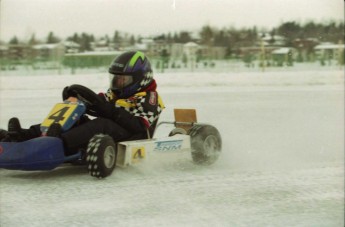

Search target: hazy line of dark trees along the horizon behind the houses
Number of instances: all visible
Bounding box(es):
[9,21,344,51]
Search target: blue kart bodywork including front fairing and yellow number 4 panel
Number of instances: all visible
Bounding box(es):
[0,98,86,171]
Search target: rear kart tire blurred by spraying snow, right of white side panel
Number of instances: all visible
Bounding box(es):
[188,125,222,165]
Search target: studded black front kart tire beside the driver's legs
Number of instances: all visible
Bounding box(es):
[86,134,117,178]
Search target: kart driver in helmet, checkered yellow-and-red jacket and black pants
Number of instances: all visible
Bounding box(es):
[0,51,164,156]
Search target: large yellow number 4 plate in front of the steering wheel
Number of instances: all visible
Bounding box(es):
[41,103,78,127]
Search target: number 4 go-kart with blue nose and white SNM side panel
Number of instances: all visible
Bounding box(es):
[0,84,222,178]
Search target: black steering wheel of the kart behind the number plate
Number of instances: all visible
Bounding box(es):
[63,84,105,116]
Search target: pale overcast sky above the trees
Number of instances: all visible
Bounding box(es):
[0,0,344,41]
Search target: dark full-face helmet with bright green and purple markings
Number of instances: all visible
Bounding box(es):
[109,51,153,98]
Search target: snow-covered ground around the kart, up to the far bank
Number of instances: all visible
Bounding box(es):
[0,69,344,227]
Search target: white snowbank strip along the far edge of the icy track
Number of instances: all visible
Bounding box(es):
[0,69,344,92]
